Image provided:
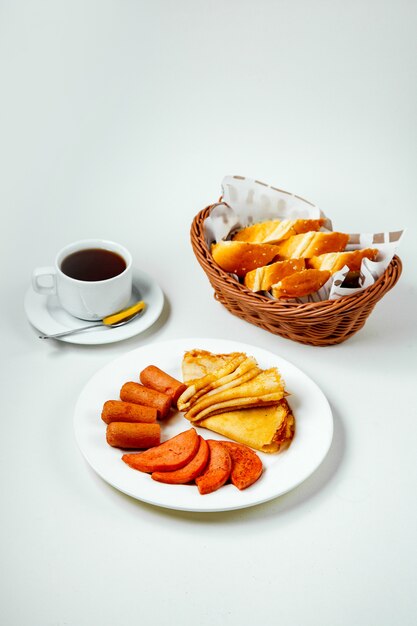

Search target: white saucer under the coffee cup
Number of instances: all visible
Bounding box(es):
[24,269,164,345]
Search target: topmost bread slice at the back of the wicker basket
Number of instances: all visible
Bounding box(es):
[232,219,325,243]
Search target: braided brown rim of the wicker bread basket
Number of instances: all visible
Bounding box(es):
[191,203,402,319]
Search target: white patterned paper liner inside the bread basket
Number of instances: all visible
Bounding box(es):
[204,176,404,303]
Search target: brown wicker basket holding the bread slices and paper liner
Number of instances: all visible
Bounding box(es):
[190,206,402,346]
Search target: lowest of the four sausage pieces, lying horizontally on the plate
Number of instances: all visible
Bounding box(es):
[106,422,161,450]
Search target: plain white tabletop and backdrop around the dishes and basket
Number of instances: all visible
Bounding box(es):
[0,0,417,626]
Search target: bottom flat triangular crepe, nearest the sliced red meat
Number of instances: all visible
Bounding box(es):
[198,398,295,454]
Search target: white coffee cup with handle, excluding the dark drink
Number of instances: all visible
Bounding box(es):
[32,239,133,321]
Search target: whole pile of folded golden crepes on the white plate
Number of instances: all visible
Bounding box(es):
[178,349,295,453]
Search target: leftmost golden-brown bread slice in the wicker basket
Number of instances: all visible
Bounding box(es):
[211,241,280,277]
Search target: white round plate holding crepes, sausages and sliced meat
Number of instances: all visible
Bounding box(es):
[74,338,333,512]
